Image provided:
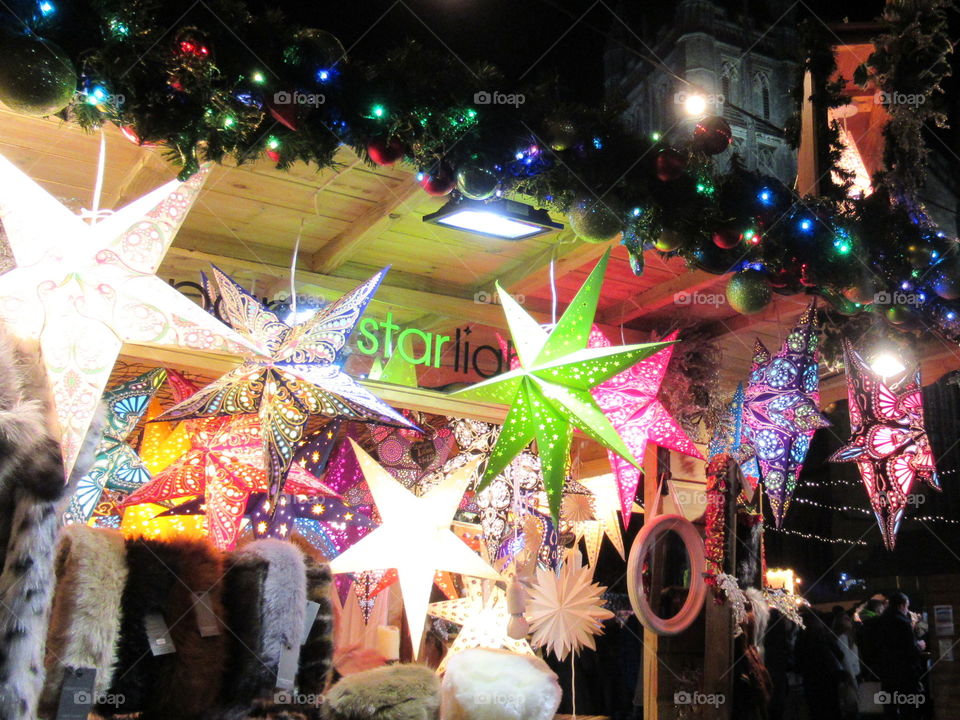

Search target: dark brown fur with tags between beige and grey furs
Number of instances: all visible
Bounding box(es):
[103,538,226,720]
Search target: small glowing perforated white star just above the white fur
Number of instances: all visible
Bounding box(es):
[429,577,533,673]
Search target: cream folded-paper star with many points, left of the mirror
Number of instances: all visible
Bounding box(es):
[527,552,613,660]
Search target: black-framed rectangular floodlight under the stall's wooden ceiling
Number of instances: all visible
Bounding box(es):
[423,198,563,240]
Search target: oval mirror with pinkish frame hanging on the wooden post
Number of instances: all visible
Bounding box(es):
[627,515,707,635]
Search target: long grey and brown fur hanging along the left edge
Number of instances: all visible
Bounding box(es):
[0,329,103,720]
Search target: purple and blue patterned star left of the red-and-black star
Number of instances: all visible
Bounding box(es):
[743,303,830,527]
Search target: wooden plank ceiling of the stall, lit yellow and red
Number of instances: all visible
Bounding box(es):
[0,110,958,404]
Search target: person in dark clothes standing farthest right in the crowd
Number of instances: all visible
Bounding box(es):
[876,592,926,719]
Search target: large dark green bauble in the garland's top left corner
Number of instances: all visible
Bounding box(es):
[0,35,77,117]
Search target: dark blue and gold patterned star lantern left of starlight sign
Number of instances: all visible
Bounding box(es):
[161,268,410,506]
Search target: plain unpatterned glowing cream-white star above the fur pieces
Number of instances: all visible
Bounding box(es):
[330,440,500,656]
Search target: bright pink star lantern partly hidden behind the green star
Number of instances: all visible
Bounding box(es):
[590,329,703,524]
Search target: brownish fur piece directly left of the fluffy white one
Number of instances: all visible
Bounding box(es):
[323,664,440,720]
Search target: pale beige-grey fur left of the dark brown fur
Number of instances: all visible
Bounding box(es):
[40,525,127,718]
